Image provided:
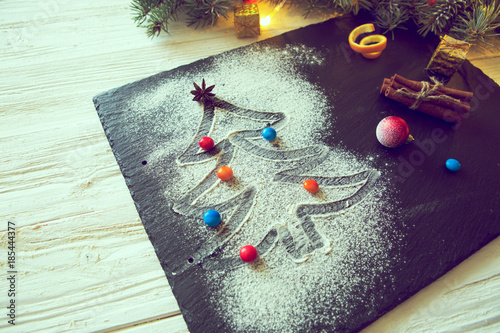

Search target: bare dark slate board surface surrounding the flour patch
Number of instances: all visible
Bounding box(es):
[94,16,500,332]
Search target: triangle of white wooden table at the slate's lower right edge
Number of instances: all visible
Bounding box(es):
[362,238,500,333]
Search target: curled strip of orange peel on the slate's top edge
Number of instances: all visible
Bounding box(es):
[349,23,387,59]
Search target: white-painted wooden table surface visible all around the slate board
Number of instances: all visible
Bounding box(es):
[0,0,500,332]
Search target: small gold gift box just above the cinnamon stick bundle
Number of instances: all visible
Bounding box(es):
[426,35,470,78]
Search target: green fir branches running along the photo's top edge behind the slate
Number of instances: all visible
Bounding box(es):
[131,0,500,43]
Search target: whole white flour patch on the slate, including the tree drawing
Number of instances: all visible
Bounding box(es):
[130,45,395,332]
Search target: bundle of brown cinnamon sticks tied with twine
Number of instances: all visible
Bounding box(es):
[380,74,473,123]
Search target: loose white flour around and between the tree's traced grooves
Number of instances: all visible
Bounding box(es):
[129,45,399,332]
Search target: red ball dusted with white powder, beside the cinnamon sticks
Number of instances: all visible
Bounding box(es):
[376,116,410,148]
